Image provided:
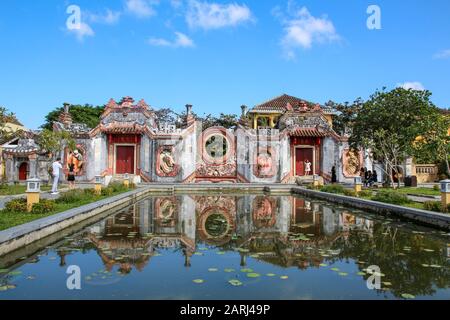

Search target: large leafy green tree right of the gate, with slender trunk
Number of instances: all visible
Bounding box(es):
[349,88,439,188]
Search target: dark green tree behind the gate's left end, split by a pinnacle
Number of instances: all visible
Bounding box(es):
[41,104,105,130]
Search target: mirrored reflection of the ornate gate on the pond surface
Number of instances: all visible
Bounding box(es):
[84,195,373,273]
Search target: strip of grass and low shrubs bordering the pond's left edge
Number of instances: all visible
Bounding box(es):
[0,189,132,230]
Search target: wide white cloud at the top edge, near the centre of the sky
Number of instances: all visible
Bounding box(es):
[186,0,252,30]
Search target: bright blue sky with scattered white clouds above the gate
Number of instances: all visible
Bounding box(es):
[0,0,450,129]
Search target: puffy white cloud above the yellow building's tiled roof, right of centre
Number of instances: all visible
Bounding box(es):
[272,1,340,59]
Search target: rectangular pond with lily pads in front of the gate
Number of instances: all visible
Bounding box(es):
[0,195,450,299]
